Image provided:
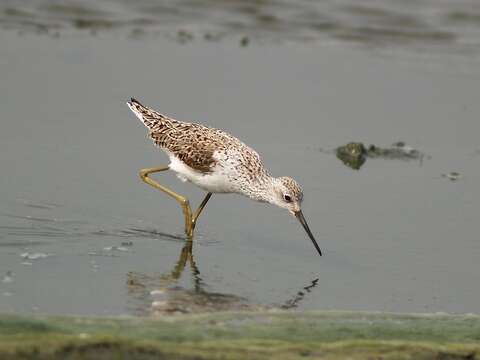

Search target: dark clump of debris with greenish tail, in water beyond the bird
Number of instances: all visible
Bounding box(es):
[335,141,425,170]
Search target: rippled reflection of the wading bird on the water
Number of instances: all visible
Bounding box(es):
[127,241,318,316]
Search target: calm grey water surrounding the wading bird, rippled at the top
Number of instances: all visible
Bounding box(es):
[0,0,480,315]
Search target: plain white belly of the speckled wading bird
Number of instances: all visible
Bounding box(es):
[169,154,235,193]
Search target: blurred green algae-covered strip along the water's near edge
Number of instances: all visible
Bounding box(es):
[0,311,480,360]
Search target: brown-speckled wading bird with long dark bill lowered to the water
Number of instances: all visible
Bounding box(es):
[127,98,322,255]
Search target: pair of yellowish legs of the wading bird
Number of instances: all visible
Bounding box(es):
[140,165,212,239]
